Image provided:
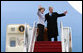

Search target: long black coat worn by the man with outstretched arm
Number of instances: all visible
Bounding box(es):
[45,12,65,36]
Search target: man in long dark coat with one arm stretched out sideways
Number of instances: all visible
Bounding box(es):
[45,7,67,41]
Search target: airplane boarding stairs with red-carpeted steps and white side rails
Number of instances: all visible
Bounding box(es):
[25,22,72,52]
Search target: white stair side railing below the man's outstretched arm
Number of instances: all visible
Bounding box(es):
[60,22,72,52]
